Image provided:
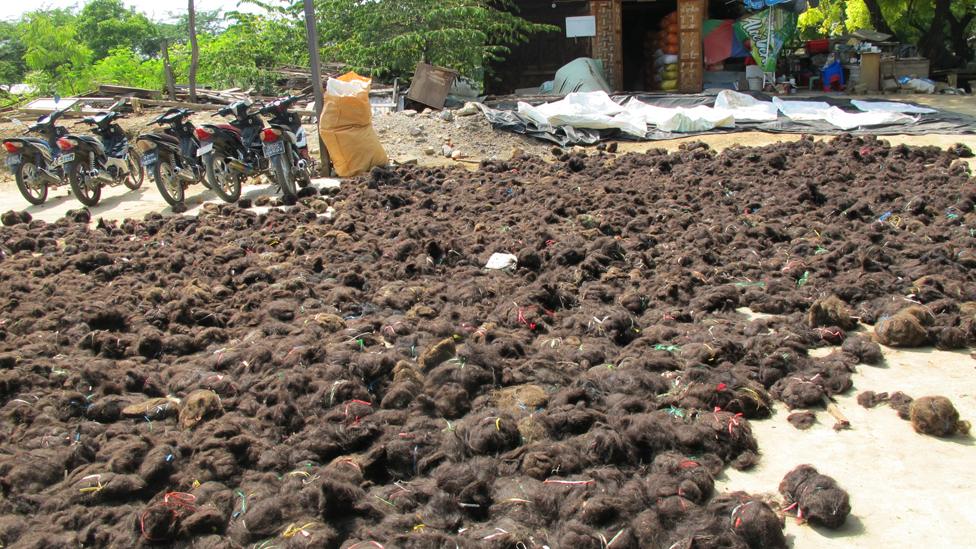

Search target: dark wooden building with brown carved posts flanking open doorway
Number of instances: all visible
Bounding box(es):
[486,0,742,94]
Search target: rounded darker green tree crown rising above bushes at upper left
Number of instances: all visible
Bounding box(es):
[78,0,159,59]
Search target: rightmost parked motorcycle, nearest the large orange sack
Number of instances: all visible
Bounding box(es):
[258,96,315,199]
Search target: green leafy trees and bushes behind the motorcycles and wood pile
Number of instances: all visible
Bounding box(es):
[9,0,558,95]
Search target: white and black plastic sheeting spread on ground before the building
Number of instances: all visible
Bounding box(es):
[482,90,976,146]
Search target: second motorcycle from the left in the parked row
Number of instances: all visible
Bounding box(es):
[57,112,145,206]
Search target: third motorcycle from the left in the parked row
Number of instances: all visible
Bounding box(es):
[136,108,207,206]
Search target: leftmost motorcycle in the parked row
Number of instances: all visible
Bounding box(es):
[3,109,68,206]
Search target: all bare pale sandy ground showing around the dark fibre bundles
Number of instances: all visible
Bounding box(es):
[0,92,976,549]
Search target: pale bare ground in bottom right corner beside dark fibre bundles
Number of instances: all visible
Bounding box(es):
[716,309,976,549]
